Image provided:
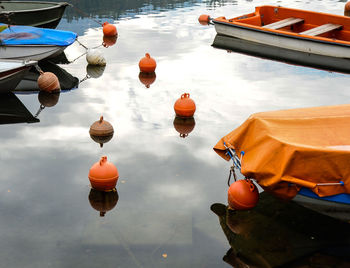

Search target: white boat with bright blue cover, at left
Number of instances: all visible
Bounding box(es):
[0,24,77,61]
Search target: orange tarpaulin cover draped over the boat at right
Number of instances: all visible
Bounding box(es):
[214,104,350,197]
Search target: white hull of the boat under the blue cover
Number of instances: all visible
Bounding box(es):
[0,45,66,61]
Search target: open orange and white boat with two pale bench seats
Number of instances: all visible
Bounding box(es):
[212,5,350,58]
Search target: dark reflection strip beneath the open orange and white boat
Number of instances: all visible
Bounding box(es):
[212,34,350,73]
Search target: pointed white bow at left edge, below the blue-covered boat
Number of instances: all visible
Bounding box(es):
[0,60,37,93]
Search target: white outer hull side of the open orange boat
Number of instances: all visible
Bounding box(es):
[214,21,350,58]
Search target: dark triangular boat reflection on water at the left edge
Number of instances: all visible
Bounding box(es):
[0,92,39,124]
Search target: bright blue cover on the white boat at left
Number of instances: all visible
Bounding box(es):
[0,23,77,46]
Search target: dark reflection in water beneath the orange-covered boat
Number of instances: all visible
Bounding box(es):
[211,192,350,267]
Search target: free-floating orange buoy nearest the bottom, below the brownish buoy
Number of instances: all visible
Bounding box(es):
[89,156,119,191]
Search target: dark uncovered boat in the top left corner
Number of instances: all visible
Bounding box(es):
[0,1,69,28]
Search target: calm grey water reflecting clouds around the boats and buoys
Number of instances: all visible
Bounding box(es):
[0,0,350,267]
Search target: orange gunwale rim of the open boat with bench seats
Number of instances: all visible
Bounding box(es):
[213,5,350,47]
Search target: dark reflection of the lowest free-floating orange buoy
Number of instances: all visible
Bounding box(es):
[89,189,119,217]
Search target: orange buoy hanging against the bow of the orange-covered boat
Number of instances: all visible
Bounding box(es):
[228,179,259,210]
